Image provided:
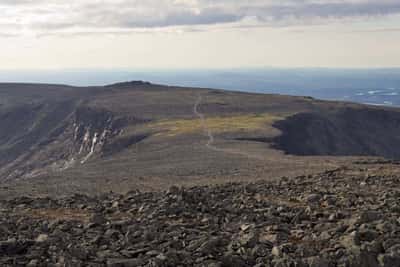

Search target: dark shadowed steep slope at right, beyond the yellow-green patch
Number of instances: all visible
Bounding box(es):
[273,107,400,159]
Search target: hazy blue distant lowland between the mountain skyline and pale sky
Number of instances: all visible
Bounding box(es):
[0,68,400,106]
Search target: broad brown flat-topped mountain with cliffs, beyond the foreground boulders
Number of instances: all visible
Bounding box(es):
[0,81,400,199]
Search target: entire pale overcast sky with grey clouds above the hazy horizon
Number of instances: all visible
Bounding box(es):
[0,0,400,69]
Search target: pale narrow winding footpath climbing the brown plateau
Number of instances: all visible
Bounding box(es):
[193,94,264,160]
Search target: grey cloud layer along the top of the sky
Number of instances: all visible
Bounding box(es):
[0,0,400,36]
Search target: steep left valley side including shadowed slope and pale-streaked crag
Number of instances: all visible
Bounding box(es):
[0,103,136,179]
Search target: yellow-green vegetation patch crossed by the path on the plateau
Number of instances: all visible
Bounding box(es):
[146,114,282,136]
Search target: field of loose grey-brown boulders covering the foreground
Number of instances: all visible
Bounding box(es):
[0,170,400,267]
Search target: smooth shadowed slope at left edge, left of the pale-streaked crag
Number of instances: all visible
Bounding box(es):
[0,101,75,179]
